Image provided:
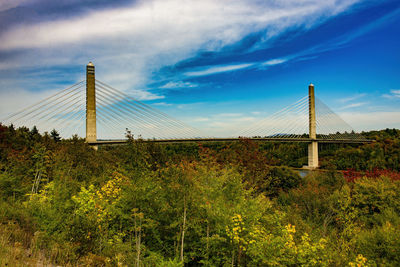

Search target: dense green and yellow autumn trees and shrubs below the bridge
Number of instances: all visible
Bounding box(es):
[0,125,400,266]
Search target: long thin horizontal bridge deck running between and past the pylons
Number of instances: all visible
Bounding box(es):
[88,138,373,145]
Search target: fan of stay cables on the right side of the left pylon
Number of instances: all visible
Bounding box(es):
[96,80,204,139]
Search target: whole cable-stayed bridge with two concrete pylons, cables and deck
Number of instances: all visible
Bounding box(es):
[2,62,370,169]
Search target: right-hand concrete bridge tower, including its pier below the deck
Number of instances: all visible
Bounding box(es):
[307,84,318,169]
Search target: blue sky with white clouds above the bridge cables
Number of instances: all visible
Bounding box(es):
[0,0,400,135]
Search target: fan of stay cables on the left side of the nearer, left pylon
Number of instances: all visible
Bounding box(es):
[2,81,85,138]
